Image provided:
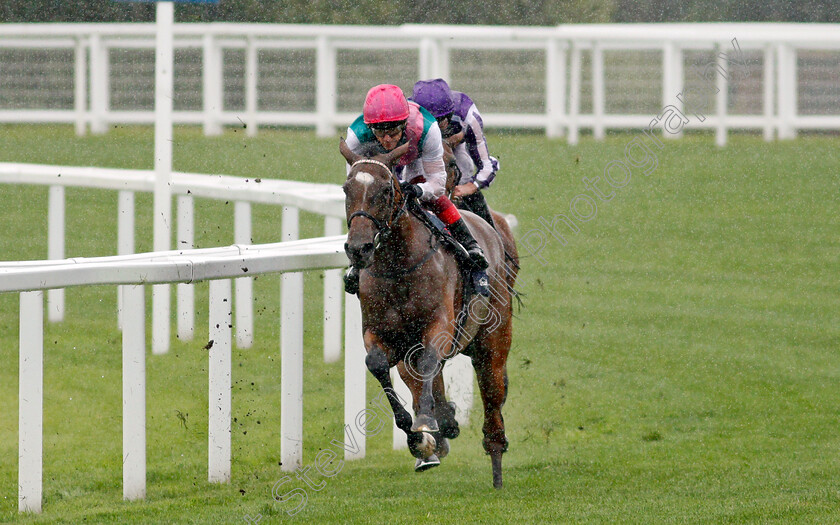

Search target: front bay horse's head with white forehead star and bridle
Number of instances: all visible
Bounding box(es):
[339,139,409,268]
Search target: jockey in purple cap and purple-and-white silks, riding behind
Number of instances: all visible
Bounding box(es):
[411,78,499,228]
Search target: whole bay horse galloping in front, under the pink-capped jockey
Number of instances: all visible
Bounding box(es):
[339,139,518,488]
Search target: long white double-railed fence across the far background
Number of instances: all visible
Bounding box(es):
[0,23,840,144]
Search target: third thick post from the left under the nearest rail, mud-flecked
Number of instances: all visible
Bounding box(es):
[207,279,232,483]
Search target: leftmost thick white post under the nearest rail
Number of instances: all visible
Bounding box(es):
[18,291,44,513]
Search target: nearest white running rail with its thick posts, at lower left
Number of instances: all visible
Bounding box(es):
[0,235,352,512]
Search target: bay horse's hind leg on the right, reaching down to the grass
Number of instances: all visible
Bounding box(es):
[473,319,511,489]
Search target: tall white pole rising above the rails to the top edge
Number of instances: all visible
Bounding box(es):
[152,2,174,354]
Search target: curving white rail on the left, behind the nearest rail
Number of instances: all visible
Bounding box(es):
[0,163,344,361]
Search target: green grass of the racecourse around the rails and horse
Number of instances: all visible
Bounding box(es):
[0,126,840,524]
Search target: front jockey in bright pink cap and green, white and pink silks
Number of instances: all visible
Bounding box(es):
[344,84,488,294]
